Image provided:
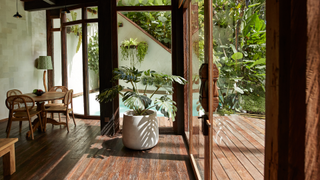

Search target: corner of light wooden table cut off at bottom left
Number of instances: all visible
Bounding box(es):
[0,138,18,176]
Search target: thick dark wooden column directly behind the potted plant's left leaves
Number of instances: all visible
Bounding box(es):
[98,0,119,135]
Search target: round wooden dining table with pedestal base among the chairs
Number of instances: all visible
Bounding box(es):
[24,92,67,137]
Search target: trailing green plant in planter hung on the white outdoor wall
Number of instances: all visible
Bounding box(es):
[120,38,148,67]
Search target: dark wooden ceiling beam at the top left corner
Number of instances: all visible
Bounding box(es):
[24,0,98,11]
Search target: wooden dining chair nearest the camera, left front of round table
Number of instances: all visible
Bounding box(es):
[6,95,42,139]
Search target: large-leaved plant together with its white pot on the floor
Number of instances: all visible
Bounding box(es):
[97,67,187,150]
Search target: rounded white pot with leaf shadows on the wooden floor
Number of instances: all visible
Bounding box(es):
[122,110,159,150]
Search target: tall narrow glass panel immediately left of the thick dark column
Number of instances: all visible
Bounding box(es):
[87,23,100,116]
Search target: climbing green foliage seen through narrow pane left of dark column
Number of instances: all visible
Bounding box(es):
[88,33,99,74]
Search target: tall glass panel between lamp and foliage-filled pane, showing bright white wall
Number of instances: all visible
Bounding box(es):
[67,25,84,115]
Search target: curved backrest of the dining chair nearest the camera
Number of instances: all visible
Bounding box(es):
[6,95,35,113]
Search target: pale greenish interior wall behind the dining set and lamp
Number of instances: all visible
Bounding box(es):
[0,0,47,119]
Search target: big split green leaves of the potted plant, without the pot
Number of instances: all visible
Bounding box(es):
[96,66,187,121]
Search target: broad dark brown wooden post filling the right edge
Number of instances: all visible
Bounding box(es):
[265,0,320,180]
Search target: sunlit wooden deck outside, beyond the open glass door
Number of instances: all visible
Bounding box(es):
[193,115,265,180]
